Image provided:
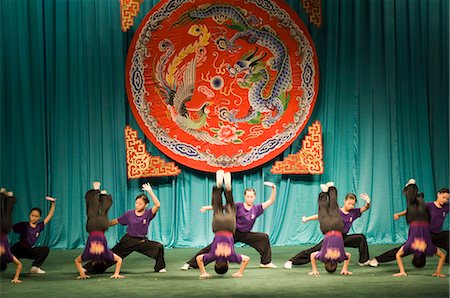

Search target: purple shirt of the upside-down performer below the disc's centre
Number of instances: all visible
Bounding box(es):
[203,232,242,266]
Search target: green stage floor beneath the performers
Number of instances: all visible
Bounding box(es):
[0,245,449,298]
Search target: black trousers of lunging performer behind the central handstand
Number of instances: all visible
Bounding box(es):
[187,230,272,268]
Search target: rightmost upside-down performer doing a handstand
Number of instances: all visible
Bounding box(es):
[393,179,445,277]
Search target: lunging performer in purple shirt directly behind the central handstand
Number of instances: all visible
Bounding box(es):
[181,178,277,270]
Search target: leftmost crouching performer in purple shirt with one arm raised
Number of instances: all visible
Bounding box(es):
[11,193,55,274]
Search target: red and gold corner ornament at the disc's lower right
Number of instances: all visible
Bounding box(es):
[270,121,324,174]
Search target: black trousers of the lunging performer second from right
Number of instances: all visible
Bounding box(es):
[289,234,369,265]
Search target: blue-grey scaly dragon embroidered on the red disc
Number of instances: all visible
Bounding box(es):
[178,4,292,127]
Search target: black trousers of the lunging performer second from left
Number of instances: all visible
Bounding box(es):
[83,234,166,273]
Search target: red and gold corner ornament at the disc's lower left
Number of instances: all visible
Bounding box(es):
[125,126,181,179]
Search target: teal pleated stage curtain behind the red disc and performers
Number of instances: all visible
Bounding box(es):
[0,0,449,249]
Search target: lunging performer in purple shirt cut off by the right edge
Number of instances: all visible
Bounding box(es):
[369,187,449,267]
